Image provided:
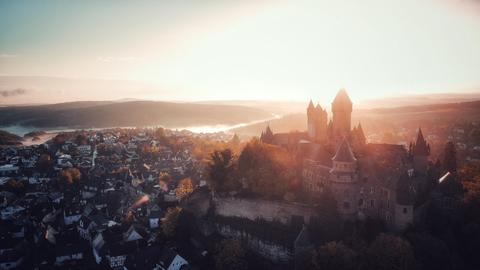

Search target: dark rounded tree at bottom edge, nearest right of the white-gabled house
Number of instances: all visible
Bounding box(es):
[214,239,248,270]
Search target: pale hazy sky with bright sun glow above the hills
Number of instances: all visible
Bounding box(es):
[0,0,480,104]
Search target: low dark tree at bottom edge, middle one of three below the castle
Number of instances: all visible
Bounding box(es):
[312,242,357,270]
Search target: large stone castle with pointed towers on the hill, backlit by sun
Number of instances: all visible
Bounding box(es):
[260,90,435,230]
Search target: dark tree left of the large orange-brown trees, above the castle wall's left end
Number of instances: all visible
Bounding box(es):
[208,148,237,192]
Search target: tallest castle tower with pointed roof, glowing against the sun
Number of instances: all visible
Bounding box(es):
[332,89,353,140]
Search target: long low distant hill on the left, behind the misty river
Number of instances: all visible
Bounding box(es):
[0,101,272,131]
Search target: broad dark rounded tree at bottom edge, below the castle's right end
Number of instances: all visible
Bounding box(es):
[366,233,415,270]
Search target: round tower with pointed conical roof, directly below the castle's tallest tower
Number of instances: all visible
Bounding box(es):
[330,137,360,219]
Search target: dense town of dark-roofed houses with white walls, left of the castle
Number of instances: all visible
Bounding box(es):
[0,128,238,269]
